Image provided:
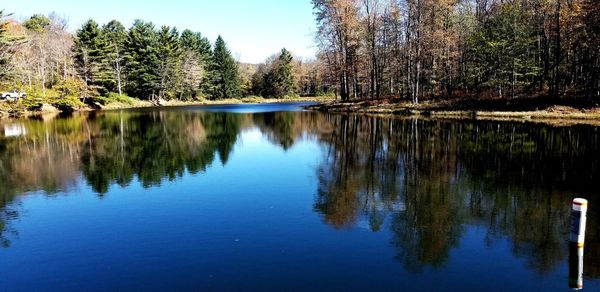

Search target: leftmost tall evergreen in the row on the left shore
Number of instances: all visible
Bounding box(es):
[74,19,110,95]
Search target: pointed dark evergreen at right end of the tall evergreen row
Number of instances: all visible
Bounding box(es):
[206,36,241,99]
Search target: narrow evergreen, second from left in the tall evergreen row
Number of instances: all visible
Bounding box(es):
[102,20,127,94]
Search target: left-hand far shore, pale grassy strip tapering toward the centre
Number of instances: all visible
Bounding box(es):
[0,97,332,119]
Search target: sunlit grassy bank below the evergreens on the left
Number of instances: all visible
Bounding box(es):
[0,95,332,118]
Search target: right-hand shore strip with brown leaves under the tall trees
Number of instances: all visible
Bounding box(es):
[307,98,600,126]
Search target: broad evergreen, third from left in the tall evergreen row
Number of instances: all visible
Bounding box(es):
[125,20,160,99]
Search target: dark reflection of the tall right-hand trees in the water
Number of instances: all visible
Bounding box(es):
[315,115,599,277]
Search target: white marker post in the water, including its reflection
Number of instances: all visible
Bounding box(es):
[569,198,587,290]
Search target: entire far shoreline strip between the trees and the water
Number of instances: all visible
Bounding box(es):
[0,97,600,126]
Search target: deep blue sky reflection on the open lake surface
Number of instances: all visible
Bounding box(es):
[0,109,600,291]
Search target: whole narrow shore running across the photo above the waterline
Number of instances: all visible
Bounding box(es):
[0,97,600,126]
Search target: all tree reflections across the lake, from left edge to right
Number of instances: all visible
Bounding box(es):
[0,111,600,278]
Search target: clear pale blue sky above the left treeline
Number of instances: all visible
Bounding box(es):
[0,0,316,63]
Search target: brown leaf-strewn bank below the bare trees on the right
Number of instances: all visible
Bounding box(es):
[306,101,600,126]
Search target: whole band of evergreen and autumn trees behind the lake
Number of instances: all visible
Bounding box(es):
[0,0,600,107]
